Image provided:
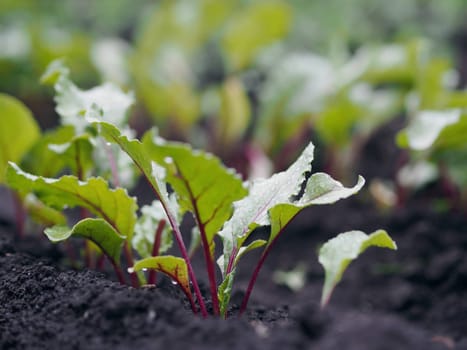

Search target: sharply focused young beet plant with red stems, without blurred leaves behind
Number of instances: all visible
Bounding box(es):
[6,63,396,317]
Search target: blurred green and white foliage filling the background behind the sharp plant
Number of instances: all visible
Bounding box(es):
[0,0,467,201]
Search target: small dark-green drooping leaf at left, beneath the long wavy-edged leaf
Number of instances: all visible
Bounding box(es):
[44,218,125,263]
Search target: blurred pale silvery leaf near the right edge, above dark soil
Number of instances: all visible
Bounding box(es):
[397,109,461,151]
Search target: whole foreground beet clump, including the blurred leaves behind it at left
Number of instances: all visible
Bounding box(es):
[0,61,396,317]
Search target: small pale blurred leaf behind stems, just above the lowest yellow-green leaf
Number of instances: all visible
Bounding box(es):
[132,200,173,258]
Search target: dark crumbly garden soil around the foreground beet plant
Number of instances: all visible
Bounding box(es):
[0,123,467,350]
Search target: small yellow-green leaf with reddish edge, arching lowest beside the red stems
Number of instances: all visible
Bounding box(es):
[129,255,191,295]
